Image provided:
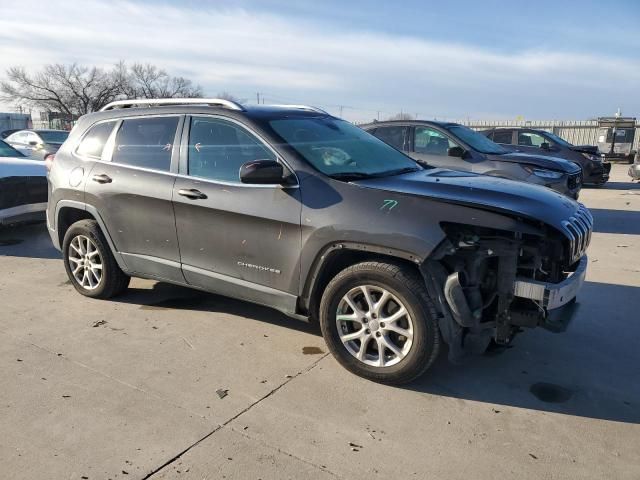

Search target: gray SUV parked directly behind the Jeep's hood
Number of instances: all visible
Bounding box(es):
[362,120,582,198]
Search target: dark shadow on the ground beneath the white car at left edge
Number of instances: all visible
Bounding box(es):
[0,222,61,258]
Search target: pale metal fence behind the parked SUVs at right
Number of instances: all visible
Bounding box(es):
[458,120,640,150]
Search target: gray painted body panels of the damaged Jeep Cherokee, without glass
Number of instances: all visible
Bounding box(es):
[48,106,578,314]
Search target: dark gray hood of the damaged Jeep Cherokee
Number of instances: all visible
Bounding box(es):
[352,168,579,231]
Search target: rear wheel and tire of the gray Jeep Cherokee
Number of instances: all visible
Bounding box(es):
[62,220,131,299]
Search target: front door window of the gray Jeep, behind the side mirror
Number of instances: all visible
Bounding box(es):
[189,117,276,182]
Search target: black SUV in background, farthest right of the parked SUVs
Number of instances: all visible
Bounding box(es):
[480,128,611,185]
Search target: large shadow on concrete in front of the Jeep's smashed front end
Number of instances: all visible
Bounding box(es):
[408,282,640,424]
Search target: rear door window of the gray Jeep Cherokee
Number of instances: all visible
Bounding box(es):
[111,117,178,172]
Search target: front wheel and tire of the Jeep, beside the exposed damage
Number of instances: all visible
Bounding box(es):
[320,262,440,385]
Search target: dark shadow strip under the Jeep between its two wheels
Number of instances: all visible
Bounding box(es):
[116,282,321,336]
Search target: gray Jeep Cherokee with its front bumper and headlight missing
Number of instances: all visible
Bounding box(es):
[47,99,592,384]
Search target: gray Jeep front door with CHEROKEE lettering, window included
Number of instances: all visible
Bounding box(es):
[173,116,302,311]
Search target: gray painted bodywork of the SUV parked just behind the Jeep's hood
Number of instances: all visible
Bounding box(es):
[362,120,580,198]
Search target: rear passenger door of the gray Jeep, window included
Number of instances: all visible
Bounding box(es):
[85,115,184,282]
